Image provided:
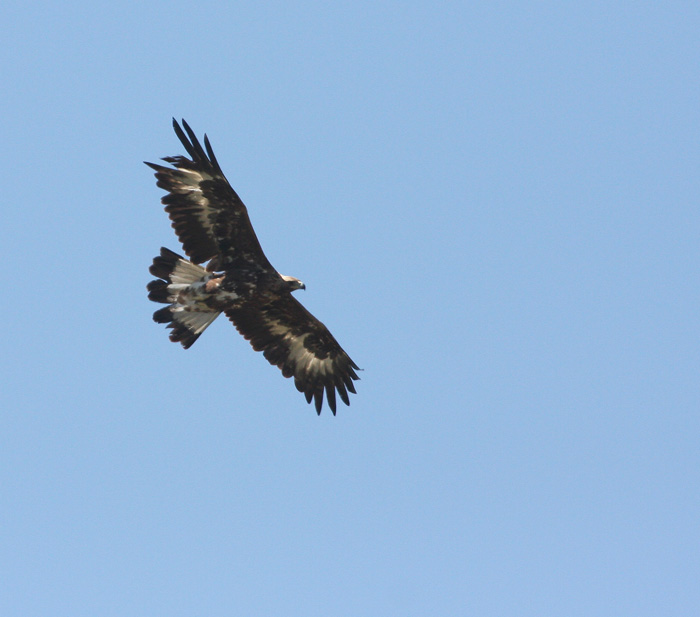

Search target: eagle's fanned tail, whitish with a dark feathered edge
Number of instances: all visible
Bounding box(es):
[147,248,220,349]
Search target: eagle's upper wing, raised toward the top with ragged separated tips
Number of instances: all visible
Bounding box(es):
[146,119,273,271]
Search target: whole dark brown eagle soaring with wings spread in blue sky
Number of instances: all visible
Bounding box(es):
[146,119,360,415]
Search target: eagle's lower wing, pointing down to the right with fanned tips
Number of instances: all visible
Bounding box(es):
[225,294,359,415]
